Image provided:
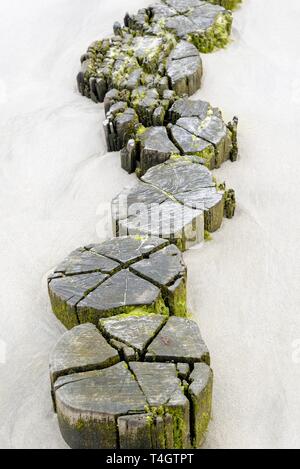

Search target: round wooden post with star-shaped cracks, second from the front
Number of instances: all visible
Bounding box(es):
[48,236,187,329]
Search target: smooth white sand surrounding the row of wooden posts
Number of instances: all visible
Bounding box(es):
[0,0,300,448]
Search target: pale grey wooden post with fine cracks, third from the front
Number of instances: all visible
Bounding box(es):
[112,155,235,251]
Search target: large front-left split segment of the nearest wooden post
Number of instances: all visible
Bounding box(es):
[56,362,147,449]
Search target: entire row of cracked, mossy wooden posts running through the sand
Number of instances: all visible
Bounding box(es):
[48,0,240,449]
